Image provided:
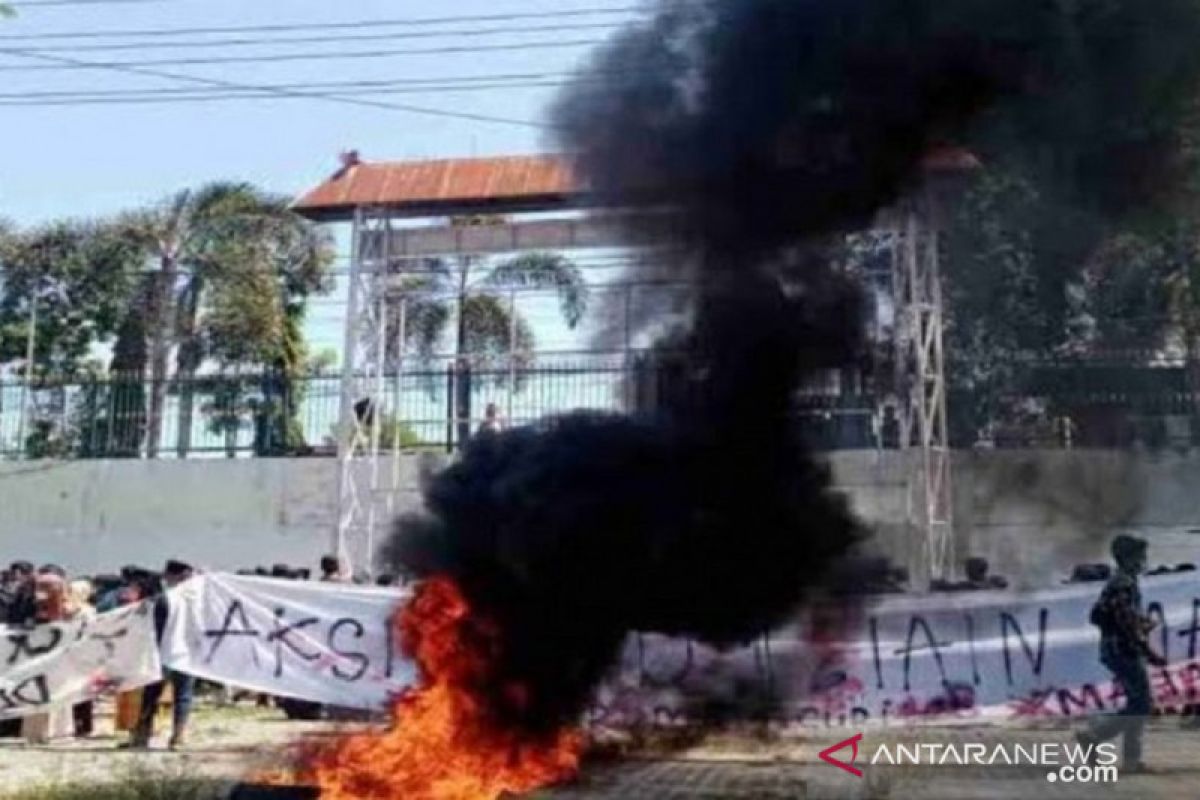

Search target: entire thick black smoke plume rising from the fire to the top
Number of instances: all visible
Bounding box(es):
[381,0,1200,730]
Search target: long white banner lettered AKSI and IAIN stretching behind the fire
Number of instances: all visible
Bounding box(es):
[163,573,1200,730]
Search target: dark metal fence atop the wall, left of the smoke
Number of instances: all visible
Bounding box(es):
[0,357,629,458]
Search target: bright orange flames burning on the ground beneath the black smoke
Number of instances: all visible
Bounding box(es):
[292,578,583,800]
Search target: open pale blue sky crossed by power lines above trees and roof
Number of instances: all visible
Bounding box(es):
[0,0,648,224]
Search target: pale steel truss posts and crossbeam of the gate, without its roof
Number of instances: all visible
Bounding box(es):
[334,181,954,578]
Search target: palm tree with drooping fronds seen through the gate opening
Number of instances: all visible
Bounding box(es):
[388,245,588,444]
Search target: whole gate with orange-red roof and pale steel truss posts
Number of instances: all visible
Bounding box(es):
[324,150,978,578]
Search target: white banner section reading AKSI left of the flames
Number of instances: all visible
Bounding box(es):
[162,575,415,709]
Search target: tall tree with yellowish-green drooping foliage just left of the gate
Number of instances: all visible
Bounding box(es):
[113,182,332,458]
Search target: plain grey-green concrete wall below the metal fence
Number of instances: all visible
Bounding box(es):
[0,450,1200,585]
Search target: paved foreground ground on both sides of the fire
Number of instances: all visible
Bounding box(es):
[0,709,1200,800]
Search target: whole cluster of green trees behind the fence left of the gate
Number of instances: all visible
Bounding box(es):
[0,184,332,456]
